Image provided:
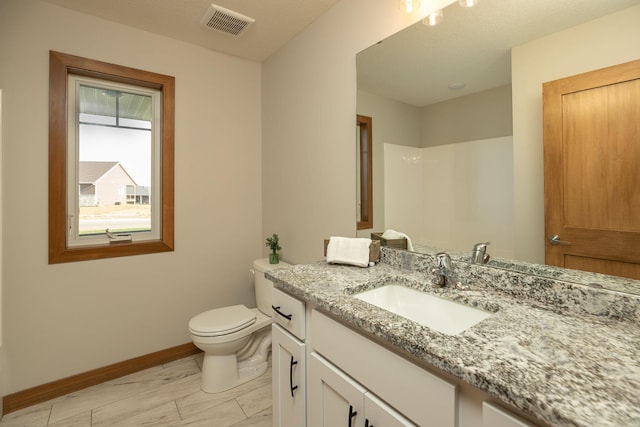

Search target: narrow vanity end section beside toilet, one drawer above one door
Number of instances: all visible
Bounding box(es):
[271,289,306,427]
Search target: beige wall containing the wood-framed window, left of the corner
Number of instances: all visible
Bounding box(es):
[0,0,264,394]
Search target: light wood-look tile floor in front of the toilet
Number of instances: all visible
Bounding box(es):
[0,354,272,427]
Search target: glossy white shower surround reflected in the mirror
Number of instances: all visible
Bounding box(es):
[384,136,514,258]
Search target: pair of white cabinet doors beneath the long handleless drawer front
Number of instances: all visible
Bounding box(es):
[307,353,416,427]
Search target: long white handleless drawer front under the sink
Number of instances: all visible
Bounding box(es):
[310,310,458,427]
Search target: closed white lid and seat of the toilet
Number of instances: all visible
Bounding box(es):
[189,305,256,337]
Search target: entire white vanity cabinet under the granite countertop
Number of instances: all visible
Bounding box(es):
[272,289,535,427]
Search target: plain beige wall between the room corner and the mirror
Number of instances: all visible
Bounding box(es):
[262,0,452,263]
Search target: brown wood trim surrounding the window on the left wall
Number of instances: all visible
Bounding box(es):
[49,51,175,264]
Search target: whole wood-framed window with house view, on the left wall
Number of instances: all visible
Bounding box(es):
[49,51,175,264]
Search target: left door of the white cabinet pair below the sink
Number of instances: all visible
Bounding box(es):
[307,353,366,427]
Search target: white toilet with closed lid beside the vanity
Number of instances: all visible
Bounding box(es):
[189,258,290,393]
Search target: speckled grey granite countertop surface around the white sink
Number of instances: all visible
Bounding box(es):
[267,262,640,427]
